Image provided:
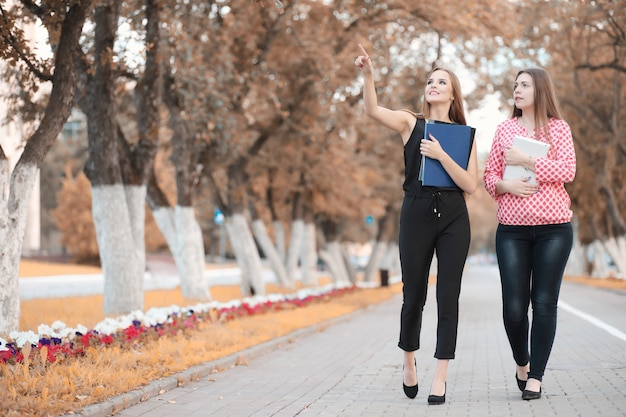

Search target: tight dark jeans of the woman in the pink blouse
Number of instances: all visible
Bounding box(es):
[496,223,573,381]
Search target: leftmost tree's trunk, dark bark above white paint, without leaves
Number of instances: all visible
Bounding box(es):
[0,0,92,334]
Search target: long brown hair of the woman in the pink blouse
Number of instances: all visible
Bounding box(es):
[511,68,563,141]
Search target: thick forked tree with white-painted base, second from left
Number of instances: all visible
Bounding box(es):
[63,0,160,314]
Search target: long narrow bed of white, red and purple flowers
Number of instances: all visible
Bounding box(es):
[0,284,357,364]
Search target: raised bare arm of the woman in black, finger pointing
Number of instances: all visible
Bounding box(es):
[354,44,415,143]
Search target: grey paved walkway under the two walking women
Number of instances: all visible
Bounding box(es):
[68,266,626,417]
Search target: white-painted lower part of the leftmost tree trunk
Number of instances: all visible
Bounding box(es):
[0,159,38,335]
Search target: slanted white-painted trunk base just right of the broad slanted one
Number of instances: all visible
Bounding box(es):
[225,213,265,296]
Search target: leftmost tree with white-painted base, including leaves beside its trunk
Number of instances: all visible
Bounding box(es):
[0,1,91,333]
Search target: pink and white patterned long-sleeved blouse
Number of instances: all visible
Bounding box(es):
[483,118,576,226]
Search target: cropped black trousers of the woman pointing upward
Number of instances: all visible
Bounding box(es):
[398,191,471,359]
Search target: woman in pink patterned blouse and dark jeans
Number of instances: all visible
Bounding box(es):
[483,68,576,400]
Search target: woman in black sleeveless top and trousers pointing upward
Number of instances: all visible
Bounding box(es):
[355,45,478,404]
